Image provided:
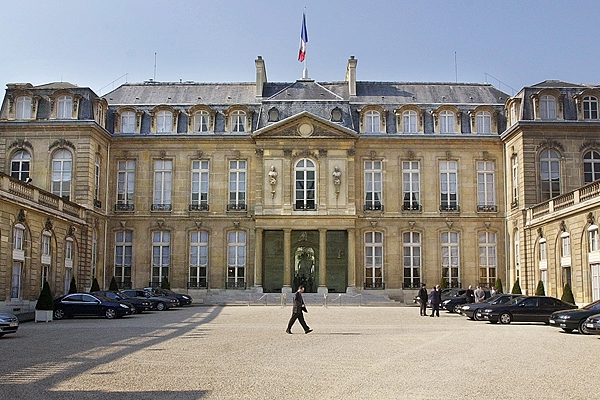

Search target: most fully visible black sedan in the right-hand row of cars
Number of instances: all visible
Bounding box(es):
[477,296,577,324]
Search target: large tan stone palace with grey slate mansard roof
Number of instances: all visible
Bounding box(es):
[0,56,600,312]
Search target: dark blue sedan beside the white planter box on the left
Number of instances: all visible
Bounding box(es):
[54,293,134,319]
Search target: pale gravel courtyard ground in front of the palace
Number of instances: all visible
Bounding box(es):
[0,306,600,400]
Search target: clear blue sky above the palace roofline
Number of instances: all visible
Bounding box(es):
[0,0,600,95]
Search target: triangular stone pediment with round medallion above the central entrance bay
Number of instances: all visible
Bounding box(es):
[252,111,358,139]
